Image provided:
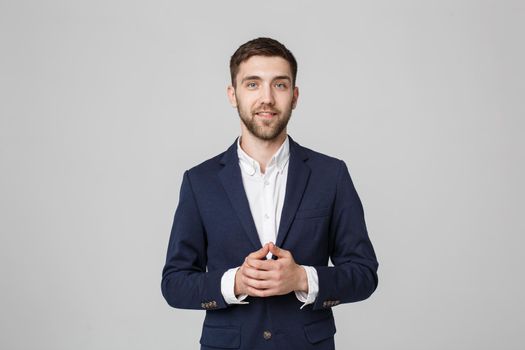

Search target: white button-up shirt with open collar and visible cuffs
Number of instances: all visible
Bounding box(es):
[221,135,319,308]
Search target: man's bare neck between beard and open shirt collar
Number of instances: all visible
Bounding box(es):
[240,129,287,173]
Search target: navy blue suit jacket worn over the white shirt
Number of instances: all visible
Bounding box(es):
[161,137,378,350]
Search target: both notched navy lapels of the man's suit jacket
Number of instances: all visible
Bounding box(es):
[219,135,310,250]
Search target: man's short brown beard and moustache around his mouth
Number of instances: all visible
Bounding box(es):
[237,98,292,141]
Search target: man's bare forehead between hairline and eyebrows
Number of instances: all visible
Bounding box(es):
[237,56,292,80]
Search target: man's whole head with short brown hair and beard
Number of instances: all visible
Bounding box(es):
[228,38,299,140]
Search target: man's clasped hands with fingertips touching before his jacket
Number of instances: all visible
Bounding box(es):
[234,242,308,297]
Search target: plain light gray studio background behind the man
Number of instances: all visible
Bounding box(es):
[0,0,525,350]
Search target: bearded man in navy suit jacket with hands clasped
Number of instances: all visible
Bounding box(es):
[162,38,378,350]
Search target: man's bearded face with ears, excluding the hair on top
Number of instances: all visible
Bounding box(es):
[228,56,299,140]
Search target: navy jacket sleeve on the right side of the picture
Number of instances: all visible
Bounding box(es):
[313,161,378,310]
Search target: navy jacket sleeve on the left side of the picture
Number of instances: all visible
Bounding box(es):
[161,171,228,310]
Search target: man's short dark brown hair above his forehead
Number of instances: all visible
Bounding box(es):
[230,38,297,88]
